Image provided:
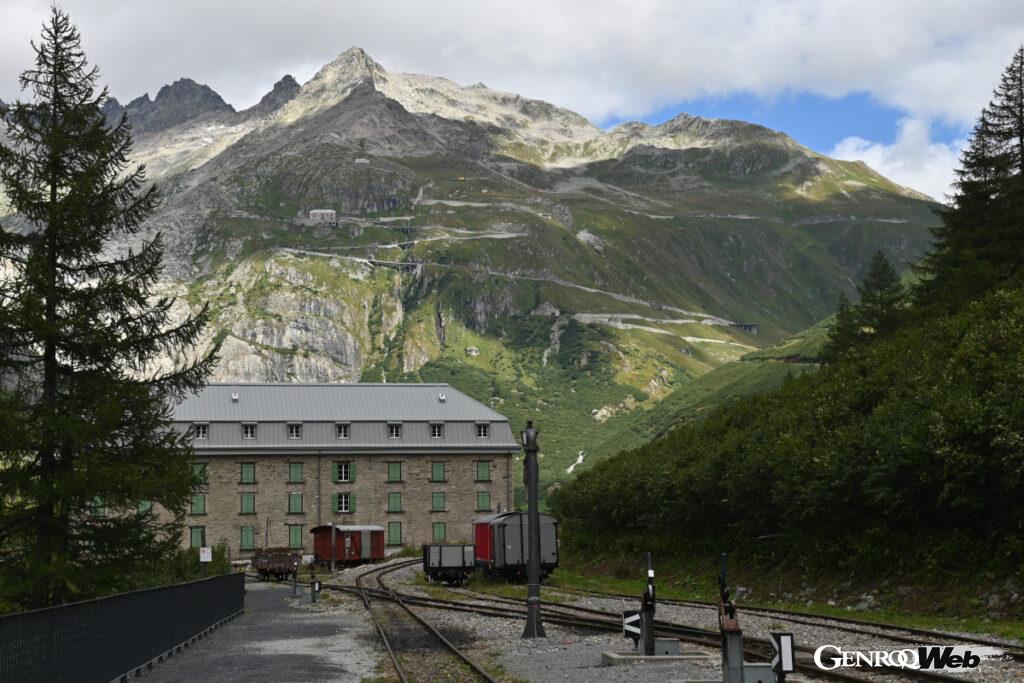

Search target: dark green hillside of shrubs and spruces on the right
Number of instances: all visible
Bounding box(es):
[551,48,1024,581]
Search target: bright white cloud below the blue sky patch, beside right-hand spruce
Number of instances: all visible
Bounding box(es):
[828,118,966,202]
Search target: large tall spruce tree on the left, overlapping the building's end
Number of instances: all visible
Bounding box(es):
[0,7,215,607]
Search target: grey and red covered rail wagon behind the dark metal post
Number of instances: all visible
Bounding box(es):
[473,512,558,581]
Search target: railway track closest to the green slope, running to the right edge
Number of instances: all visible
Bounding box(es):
[553,587,1024,661]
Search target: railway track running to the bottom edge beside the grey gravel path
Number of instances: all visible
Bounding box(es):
[337,560,498,683]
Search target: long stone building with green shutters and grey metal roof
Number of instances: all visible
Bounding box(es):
[174,384,518,559]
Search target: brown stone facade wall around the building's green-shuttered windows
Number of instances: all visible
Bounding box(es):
[182,454,512,559]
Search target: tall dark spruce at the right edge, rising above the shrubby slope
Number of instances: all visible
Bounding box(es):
[914,47,1024,309]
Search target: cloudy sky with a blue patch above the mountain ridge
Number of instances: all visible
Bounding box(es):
[0,0,1024,198]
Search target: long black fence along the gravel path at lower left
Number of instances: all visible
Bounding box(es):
[0,573,245,682]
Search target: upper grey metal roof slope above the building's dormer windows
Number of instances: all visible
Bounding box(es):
[174,384,508,422]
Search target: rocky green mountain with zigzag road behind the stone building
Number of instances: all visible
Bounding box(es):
[2,48,936,479]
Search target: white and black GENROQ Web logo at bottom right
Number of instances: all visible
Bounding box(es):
[814,645,1002,671]
